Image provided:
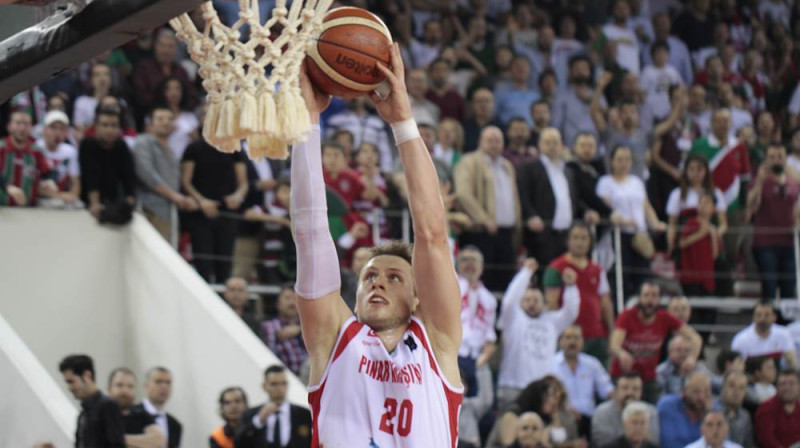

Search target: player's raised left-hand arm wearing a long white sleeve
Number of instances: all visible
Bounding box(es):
[291,66,352,384]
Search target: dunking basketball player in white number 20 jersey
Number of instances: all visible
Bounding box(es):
[291,45,463,448]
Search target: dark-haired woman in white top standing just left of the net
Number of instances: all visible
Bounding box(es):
[156,77,200,160]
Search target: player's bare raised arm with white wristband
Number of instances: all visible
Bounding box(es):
[371,44,461,356]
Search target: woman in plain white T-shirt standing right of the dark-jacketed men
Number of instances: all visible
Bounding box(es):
[595,146,667,296]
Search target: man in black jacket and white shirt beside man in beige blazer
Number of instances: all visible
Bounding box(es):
[517,128,584,266]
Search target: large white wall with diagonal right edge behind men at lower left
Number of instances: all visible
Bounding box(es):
[0,209,306,447]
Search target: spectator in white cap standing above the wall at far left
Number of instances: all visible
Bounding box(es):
[36,110,81,207]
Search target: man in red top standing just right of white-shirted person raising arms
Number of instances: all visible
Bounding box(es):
[542,223,614,365]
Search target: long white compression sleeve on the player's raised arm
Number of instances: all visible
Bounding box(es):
[291,124,342,299]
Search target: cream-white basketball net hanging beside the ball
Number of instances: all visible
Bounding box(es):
[170,0,333,159]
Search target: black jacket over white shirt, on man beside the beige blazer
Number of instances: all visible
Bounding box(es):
[517,160,583,227]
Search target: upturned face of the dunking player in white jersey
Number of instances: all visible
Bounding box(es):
[356,255,419,331]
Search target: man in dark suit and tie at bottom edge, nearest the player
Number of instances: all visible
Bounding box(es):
[236,365,311,448]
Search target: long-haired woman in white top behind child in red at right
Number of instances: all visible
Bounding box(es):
[667,154,728,253]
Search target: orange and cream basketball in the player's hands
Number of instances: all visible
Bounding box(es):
[305,7,392,98]
